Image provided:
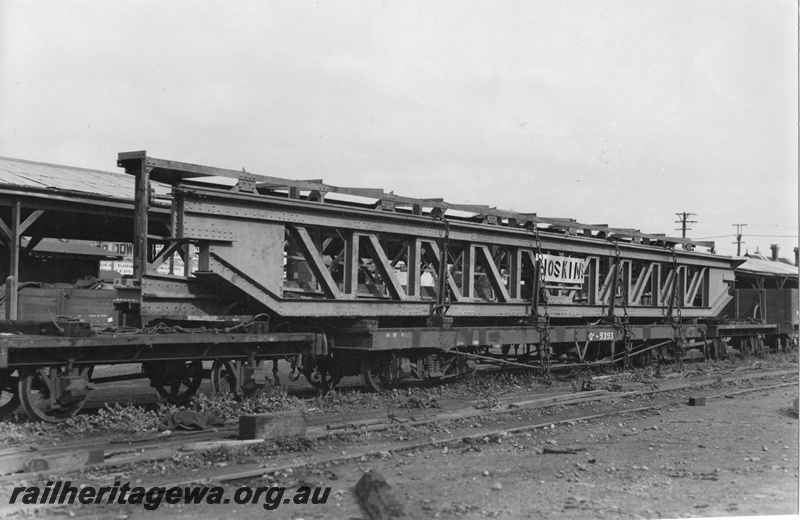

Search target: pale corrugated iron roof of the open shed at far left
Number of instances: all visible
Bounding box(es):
[0,157,169,201]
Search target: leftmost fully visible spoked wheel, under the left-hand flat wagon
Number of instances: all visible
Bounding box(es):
[17,367,91,423]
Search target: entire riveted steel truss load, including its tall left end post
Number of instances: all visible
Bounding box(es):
[119,152,733,320]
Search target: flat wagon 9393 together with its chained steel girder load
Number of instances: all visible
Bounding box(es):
[114,152,735,388]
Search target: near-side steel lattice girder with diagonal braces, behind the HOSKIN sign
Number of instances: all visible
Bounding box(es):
[154,185,732,317]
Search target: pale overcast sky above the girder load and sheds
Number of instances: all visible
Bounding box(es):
[0,0,800,258]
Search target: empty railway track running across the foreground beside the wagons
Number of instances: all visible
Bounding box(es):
[0,370,797,486]
